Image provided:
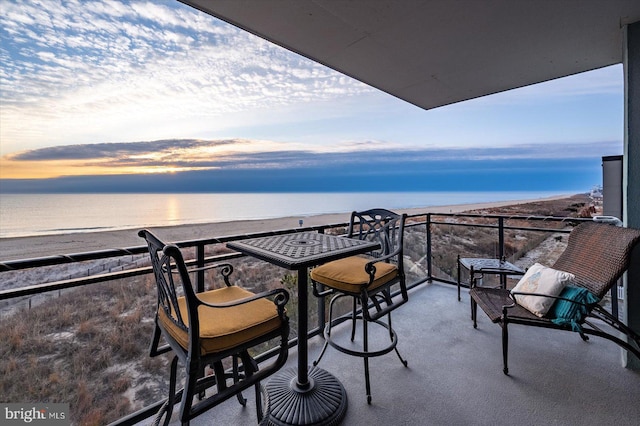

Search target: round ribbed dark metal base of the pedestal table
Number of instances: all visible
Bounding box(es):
[261,367,347,426]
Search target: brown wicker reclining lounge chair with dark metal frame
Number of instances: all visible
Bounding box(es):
[470,222,640,374]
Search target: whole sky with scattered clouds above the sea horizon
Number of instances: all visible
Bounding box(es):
[0,0,623,192]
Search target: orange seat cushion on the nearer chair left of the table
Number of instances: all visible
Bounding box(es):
[158,286,282,355]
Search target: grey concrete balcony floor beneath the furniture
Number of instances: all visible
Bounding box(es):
[152,283,640,426]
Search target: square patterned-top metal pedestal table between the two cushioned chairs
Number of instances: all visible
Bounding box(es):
[227,232,380,425]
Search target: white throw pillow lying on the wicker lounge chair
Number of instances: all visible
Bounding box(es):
[511,263,575,317]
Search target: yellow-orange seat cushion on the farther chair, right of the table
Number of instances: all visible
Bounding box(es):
[311,256,398,293]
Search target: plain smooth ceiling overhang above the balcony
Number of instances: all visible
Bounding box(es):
[181,0,640,109]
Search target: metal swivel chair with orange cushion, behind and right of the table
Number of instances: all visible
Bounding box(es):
[310,209,408,404]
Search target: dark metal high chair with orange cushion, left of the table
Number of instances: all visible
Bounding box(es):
[138,230,289,425]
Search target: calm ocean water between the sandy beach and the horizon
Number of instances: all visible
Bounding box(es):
[0,191,571,238]
